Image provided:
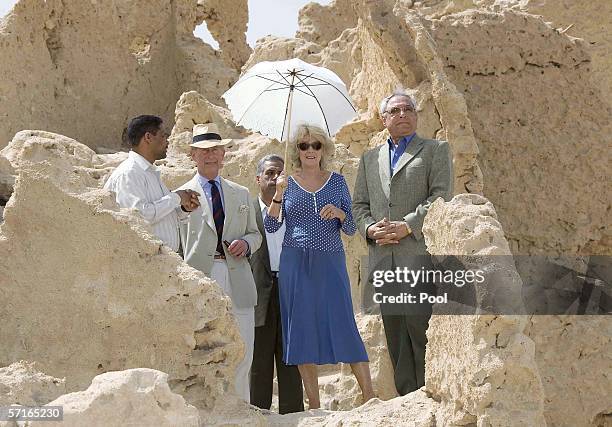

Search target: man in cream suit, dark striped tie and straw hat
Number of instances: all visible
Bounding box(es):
[180,124,261,402]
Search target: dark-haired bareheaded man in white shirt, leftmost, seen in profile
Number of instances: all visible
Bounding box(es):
[104,115,200,252]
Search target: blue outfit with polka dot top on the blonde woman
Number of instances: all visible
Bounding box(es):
[264,172,368,365]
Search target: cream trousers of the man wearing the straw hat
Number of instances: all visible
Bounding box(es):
[210,259,255,402]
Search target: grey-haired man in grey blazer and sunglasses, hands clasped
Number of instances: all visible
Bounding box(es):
[353,91,452,395]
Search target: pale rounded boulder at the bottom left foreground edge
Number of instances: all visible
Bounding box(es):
[32,368,200,427]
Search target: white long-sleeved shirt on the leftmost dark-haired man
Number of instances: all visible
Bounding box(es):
[104,151,187,251]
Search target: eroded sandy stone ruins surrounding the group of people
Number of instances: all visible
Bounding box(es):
[0,0,612,427]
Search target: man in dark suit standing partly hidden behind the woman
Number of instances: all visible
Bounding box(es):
[250,155,304,414]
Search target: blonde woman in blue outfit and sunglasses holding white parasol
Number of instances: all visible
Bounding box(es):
[264,125,374,409]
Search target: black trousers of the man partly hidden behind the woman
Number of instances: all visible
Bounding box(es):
[251,279,304,414]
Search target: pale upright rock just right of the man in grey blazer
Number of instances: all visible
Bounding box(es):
[423,195,545,426]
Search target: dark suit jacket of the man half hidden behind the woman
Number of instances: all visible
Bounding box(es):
[249,197,272,327]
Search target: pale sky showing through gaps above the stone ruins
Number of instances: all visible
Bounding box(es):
[0,0,331,48]
